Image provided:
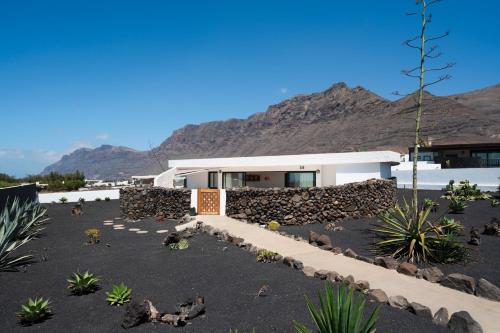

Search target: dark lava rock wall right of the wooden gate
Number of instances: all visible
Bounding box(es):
[226,179,396,224]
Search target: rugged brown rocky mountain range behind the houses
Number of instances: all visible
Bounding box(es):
[43,83,500,178]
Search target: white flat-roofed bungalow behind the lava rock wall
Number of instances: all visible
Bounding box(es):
[154,151,401,189]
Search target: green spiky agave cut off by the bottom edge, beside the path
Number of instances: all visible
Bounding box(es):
[294,282,380,333]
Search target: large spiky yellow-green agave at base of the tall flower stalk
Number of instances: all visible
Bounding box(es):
[374,201,465,262]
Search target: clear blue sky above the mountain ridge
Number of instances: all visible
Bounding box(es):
[0,0,500,176]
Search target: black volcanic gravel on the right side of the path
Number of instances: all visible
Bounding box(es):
[280,190,500,286]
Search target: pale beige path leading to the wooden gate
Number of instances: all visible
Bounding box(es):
[196,215,500,332]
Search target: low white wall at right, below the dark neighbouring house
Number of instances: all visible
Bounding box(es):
[392,168,500,191]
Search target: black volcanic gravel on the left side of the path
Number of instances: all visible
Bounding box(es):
[0,201,446,333]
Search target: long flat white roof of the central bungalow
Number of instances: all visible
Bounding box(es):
[168,151,401,168]
